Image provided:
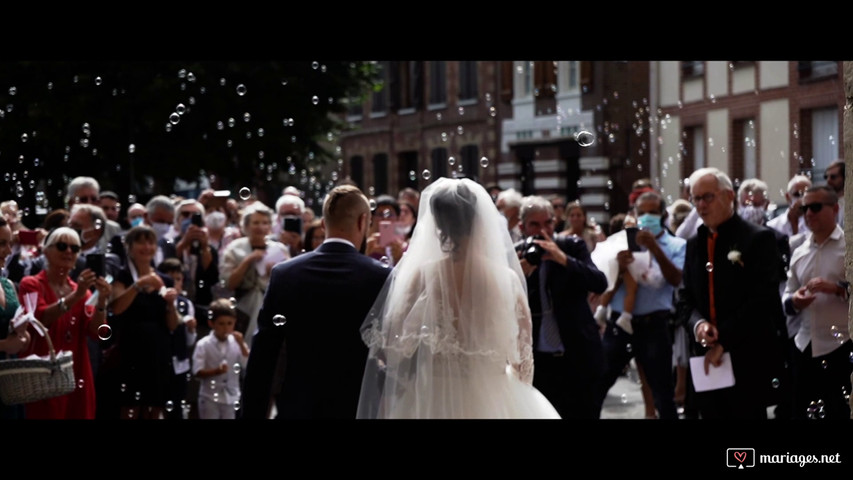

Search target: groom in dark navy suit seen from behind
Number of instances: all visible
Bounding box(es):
[242,185,390,419]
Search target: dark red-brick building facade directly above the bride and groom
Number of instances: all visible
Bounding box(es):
[339,61,501,195]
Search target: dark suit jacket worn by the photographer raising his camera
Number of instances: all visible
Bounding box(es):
[527,235,607,377]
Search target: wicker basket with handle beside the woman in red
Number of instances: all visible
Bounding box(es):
[0,320,75,405]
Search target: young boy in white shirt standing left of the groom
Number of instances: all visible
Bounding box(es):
[192,298,249,419]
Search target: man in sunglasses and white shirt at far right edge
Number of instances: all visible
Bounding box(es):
[783,186,853,420]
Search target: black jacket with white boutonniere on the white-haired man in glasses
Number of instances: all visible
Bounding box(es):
[682,214,787,406]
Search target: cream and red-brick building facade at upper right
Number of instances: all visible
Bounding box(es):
[650,61,845,203]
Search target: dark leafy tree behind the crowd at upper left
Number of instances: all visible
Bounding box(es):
[0,61,377,219]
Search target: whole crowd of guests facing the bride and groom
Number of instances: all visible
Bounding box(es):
[0,158,853,419]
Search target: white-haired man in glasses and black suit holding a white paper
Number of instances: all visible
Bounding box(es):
[680,168,785,419]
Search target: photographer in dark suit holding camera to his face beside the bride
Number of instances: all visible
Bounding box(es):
[519,196,607,419]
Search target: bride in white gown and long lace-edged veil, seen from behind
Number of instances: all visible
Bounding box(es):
[358,178,560,418]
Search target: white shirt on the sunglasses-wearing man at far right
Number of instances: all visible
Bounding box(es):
[782,224,850,357]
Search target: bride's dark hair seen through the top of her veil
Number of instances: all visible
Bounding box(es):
[429,182,477,252]
